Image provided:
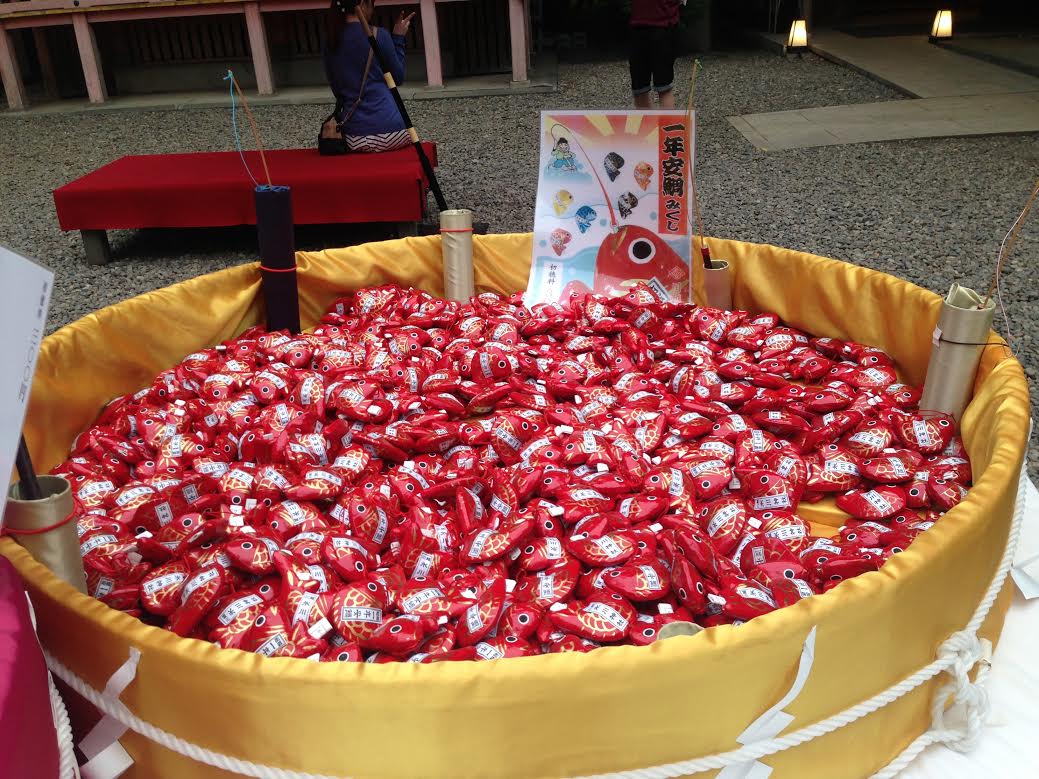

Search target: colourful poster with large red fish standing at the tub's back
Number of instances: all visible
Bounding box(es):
[525,111,695,305]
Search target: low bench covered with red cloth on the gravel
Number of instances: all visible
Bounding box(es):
[54,143,436,265]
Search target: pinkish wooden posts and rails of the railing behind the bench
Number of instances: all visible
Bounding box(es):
[0,0,529,108]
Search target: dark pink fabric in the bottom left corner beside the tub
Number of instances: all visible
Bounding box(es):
[0,557,58,779]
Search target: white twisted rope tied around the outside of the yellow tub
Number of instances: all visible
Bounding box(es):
[44,454,1028,779]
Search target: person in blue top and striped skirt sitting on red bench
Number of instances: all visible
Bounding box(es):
[324,0,415,152]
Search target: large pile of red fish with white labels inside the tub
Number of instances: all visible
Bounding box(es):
[54,287,970,663]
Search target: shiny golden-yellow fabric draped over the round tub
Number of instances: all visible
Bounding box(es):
[0,235,1029,779]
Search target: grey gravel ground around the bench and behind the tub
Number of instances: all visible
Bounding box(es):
[0,52,1039,477]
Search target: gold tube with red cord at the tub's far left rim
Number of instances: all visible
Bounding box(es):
[3,476,86,595]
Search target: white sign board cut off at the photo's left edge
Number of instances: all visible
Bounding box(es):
[0,245,54,523]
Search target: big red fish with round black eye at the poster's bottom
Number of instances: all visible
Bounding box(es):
[561,224,689,300]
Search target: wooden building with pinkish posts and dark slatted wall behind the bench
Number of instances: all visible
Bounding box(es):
[0,0,530,108]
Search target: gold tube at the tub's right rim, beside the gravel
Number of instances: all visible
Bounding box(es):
[920,284,995,422]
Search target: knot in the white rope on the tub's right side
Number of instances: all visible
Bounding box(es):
[931,630,992,752]
